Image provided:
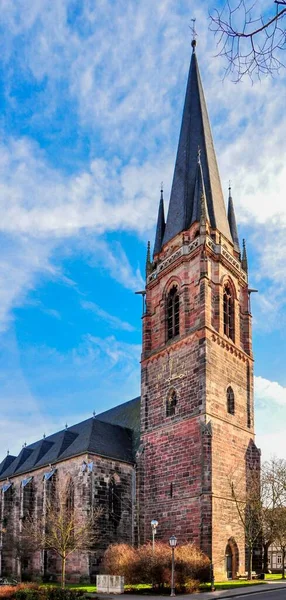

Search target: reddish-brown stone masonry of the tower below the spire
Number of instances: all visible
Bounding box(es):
[140,220,257,578]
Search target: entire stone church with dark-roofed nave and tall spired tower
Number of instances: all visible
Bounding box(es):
[0,40,260,581]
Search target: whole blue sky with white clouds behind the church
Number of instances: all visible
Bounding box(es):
[0,0,286,458]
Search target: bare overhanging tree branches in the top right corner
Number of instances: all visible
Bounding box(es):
[210,0,286,82]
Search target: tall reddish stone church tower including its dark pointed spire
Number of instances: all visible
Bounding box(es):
[139,41,259,578]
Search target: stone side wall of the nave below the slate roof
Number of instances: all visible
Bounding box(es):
[1,454,136,581]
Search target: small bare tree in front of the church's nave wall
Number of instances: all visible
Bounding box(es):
[22,481,102,588]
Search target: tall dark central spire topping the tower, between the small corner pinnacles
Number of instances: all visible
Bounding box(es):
[163,40,232,244]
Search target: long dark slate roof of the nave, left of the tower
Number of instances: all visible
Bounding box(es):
[0,397,140,480]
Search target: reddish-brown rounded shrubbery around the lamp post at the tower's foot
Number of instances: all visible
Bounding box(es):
[103,542,210,593]
